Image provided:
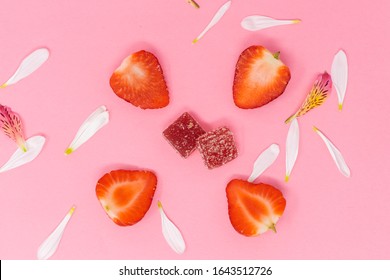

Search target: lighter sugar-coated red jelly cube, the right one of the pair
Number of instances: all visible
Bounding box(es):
[197,127,238,169]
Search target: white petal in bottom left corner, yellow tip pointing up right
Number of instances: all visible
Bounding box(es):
[37,206,76,260]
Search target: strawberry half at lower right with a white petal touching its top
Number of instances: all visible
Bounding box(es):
[226,179,286,236]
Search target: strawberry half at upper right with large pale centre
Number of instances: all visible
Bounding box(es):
[233,46,291,109]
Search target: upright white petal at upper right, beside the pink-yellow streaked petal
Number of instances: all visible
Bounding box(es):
[331,50,348,110]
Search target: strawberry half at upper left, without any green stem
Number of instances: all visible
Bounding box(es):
[110,50,169,109]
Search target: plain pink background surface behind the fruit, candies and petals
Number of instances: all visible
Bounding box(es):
[0,0,390,259]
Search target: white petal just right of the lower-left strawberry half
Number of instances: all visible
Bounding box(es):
[158,201,186,254]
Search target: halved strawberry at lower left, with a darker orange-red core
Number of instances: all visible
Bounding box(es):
[96,170,157,226]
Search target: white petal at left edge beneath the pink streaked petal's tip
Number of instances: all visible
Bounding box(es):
[0,135,46,173]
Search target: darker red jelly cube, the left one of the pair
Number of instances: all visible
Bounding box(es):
[163,112,206,158]
